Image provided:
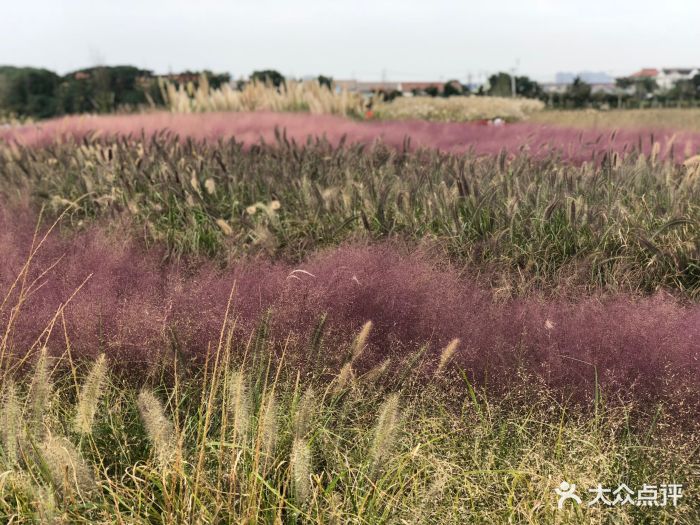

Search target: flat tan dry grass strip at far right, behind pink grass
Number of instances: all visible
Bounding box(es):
[528,108,700,132]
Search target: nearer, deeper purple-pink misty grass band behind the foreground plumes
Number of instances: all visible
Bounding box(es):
[0,210,700,407]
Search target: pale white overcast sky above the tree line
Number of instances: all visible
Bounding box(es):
[5,0,700,81]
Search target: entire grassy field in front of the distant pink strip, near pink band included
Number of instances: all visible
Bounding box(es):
[0,116,700,525]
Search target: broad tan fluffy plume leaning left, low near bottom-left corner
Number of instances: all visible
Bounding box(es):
[40,434,94,497]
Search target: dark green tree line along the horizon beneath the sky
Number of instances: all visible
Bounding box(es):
[0,66,700,119]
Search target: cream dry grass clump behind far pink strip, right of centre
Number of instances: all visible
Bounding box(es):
[375,96,544,122]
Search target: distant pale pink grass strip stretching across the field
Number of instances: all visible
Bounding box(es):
[0,112,700,162]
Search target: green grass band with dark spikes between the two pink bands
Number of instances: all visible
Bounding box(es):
[0,134,700,299]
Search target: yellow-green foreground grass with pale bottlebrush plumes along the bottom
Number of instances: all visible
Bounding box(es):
[0,340,700,524]
